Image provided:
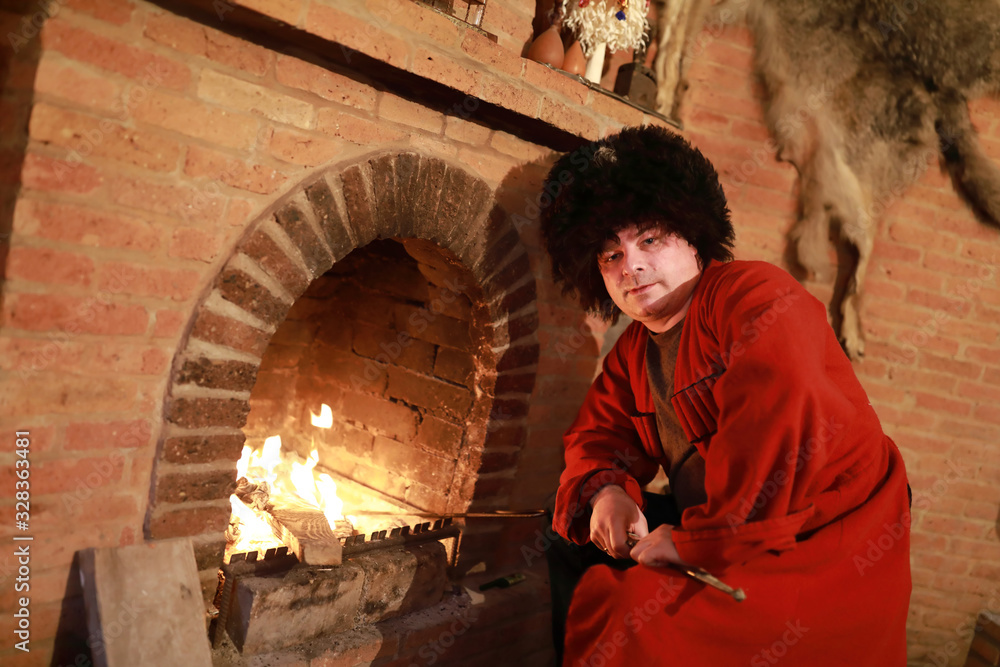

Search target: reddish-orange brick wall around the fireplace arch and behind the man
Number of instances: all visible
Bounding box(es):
[0,0,1000,665]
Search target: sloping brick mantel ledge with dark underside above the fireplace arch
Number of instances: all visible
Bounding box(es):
[170,0,676,150]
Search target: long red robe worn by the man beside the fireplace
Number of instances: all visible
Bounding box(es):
[554,262,910,667]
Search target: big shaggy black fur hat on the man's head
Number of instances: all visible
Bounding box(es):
[541,126,734,321]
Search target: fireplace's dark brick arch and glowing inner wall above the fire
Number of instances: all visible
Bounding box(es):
[145,152,538,656]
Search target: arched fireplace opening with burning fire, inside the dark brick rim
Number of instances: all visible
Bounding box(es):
[219,238,495,652]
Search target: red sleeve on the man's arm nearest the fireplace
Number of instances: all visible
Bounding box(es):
[553,325,659,544]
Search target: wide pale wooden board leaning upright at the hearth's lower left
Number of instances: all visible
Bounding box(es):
[79,538,212,667]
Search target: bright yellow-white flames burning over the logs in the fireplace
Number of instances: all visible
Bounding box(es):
[227,430,344,553]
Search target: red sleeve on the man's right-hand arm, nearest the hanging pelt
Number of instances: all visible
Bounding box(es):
[673,264,863,572]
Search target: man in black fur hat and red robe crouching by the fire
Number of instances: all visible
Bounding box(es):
[542,127,910,667]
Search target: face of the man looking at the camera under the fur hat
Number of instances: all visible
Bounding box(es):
[597,225,701,333]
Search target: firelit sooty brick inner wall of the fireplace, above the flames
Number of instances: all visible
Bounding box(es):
[243,240,484,514]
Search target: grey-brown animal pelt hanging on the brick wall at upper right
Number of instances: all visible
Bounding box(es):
[747,0,1000,358]
